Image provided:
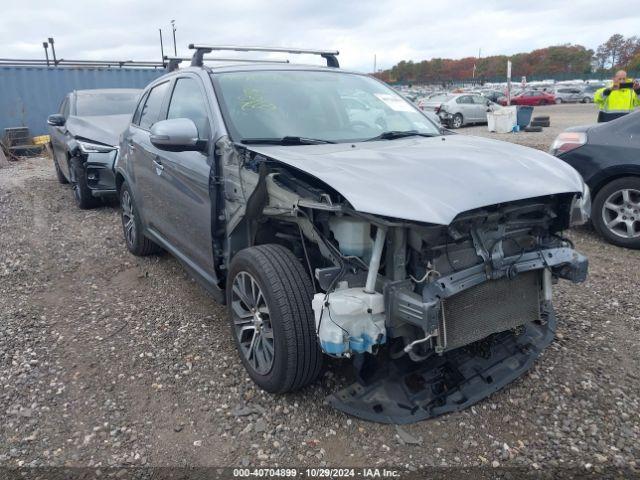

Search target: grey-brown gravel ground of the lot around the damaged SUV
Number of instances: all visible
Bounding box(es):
[0,105,640,473]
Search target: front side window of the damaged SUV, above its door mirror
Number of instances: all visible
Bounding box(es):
[167,77,211,139]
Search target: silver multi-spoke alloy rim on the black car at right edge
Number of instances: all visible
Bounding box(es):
[602,188,640,238]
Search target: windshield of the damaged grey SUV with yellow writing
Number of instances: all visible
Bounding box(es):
[213,70,440,143]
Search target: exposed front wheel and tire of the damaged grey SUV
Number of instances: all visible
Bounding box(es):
[227,245,322,393]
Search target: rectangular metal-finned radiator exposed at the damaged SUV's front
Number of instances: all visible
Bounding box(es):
[438,270,541,351]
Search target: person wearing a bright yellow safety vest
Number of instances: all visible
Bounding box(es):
[593,70,640,122]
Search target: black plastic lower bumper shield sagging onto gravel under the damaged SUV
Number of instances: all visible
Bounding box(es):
[327,309,556,424]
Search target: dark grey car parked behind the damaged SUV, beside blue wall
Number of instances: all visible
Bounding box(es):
[47,89,141,208]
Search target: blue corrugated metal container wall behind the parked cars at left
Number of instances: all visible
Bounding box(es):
[0,66,165,138]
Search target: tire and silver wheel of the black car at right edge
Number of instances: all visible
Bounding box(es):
[592,177,640,249]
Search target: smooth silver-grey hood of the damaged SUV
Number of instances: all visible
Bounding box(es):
[249,135,583,225]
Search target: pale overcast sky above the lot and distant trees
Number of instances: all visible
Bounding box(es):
[0,0,640,72]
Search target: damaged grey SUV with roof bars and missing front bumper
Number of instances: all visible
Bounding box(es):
[116,46,590,423]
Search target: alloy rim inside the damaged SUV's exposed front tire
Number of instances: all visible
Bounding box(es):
[231,271,274,375]
